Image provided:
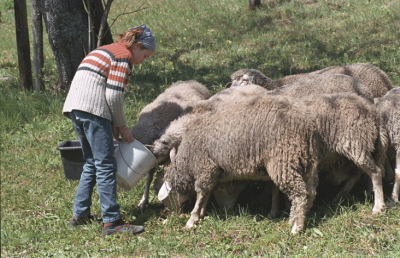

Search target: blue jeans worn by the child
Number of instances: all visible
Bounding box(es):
[69,110,121,223]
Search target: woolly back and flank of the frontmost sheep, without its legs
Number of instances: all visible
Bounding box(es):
[165,93,317,196]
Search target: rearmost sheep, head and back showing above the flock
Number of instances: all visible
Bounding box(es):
[226,63,393,98]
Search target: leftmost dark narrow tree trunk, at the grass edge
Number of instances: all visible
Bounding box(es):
[14,0,32,90]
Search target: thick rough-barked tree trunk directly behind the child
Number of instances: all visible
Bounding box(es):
[42,0,89,91]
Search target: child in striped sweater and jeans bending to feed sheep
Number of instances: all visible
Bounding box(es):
[63,24,156,236]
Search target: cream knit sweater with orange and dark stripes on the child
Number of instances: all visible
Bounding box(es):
[63,43,133,126]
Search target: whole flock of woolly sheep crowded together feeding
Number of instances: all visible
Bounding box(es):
[132,63,400,234]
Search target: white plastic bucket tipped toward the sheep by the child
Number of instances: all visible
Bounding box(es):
[115,140,157,190]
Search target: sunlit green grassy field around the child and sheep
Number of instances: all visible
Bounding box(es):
[0,0,400,257]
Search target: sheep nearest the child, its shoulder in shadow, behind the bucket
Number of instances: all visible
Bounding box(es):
[131,80,211,211]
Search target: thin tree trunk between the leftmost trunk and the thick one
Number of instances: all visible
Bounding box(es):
[31,0,44,92]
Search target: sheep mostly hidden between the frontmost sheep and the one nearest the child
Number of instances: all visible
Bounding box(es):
[148,85,268,214]
